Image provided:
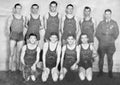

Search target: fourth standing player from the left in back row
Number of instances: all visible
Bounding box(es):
[61,4,79,45]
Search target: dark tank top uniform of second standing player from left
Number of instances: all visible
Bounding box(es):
[26,15,41,40]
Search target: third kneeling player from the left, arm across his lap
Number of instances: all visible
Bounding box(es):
[59,34,80,80]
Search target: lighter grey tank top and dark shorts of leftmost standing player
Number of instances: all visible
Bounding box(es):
[10,15,24,41]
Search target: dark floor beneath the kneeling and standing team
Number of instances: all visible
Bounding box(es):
[0,71,120,85]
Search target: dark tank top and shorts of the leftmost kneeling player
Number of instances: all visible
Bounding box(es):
[23,45,37,80]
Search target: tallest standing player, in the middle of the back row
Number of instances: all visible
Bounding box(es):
[44,1,61,41]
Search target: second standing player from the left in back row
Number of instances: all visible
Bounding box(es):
[26,4,45,49]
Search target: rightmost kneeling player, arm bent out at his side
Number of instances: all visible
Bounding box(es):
[78,34,97,81]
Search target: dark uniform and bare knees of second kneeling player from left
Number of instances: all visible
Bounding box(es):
[42,42,59,82]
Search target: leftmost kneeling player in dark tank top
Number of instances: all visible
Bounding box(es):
[21,34,40,81]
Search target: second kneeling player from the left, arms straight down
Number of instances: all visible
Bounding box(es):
[42,32,61,82]
